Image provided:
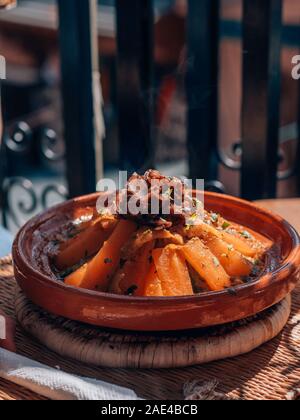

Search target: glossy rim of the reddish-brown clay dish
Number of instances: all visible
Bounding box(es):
[12,192,300,304]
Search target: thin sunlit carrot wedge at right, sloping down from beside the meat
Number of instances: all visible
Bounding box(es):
[187,223,257,258]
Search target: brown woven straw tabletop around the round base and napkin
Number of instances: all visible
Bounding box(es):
[0,259,300,400]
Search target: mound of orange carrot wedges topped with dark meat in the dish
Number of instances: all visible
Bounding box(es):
[48,171,277,297]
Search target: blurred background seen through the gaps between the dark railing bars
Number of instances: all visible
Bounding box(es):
[0,0,300,230]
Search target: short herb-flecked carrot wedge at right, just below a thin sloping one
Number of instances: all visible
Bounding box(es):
[206,238,253,277]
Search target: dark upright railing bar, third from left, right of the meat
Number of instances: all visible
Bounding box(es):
[186,0,220,181]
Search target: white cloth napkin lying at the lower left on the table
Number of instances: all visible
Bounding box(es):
[0,349,139,401]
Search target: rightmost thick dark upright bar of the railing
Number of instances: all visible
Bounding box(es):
[241,0,282,200]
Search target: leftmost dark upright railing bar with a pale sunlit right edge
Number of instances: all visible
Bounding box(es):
[58,0,102,197]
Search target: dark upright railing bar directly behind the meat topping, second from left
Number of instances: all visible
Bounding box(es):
[116,0,154,172]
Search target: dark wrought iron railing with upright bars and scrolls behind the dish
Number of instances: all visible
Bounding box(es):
[1,0,300,230]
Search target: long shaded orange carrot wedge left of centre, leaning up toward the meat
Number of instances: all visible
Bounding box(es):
[80,220,136,291]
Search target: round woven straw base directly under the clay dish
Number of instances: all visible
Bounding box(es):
[15,290,291,369]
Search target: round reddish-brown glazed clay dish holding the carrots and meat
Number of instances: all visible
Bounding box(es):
[13,193,300,331]
